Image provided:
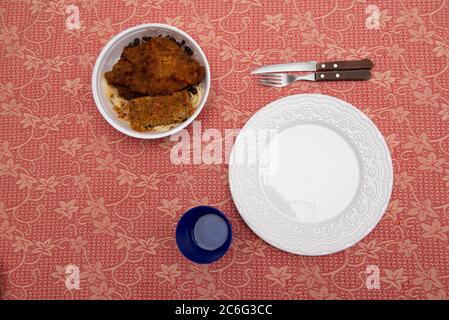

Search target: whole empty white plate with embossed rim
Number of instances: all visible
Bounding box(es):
[229,94,393,255]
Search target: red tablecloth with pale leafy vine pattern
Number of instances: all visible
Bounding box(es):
[0,0,449,299]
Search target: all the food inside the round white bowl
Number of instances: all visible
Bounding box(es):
[104,37,205,131]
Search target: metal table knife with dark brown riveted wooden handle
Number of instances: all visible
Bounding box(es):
[251,59,374,74]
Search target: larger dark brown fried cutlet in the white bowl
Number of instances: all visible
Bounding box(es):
[105,37,205,99]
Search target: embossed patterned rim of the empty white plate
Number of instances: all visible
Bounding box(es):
[229,94,393,256]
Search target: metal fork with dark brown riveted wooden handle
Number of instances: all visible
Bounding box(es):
[258,70,371,88]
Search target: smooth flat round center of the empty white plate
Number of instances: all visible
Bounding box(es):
[260,124,360,223]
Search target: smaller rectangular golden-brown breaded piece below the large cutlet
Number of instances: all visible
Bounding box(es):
[123,90,194,131]
